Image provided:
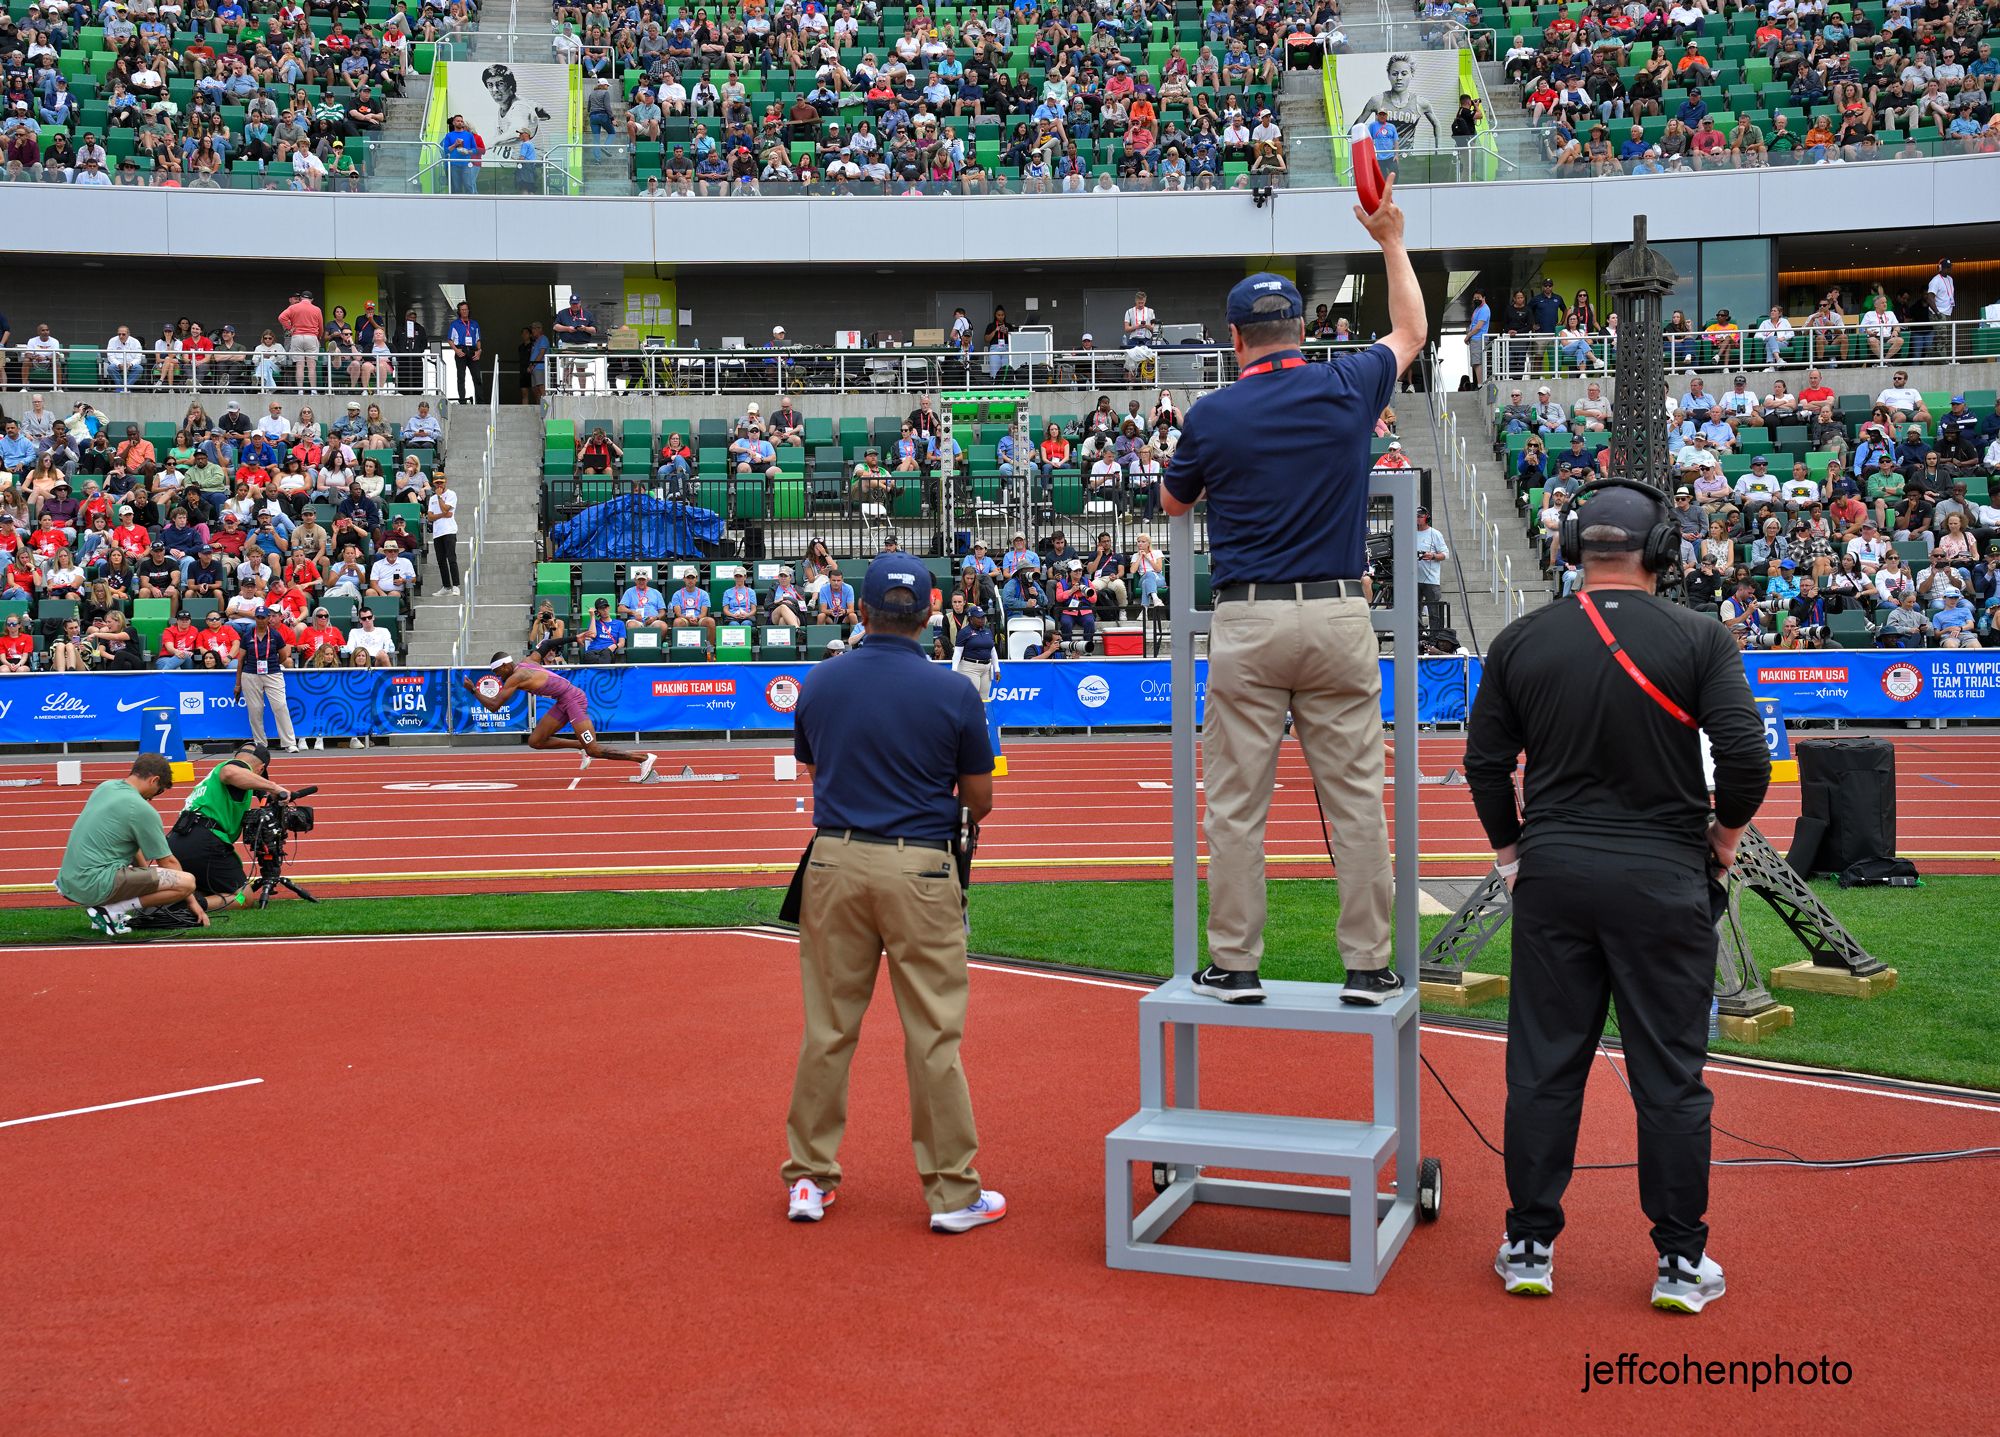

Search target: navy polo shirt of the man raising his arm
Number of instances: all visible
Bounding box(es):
[1166,344,1396,586]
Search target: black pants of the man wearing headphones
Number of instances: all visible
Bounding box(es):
[1506,849,1718,1261]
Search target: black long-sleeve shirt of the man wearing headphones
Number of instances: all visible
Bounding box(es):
[1466,588,1770,867]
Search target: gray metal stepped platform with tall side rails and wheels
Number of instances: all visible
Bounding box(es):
[1104,472,1422,1293]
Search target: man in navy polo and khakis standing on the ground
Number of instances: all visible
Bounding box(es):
[784,554,1006,1233]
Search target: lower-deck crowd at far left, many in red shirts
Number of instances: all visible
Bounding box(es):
[0,394,444,670]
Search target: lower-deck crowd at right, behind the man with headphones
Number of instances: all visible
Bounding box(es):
[1498,354,2000,648]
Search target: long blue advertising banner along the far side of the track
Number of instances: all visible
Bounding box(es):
[11,648,2000,745]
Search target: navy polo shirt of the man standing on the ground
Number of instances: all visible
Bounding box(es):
[792,634,994,841]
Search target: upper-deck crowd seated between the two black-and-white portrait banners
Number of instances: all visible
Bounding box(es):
[556,0,1360,196]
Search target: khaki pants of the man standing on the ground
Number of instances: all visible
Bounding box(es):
[784,837,980,1213]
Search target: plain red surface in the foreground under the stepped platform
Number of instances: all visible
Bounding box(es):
[0,935,2000,1437]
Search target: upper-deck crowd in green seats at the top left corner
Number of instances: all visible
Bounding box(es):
[0,0,418,190]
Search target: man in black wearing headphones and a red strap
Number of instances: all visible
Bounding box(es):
[1466,478,1770,1313]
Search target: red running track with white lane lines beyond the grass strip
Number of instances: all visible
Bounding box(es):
[0,733,2000,903]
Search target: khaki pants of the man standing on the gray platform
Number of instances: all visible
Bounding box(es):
[1202,598,1394,971]
